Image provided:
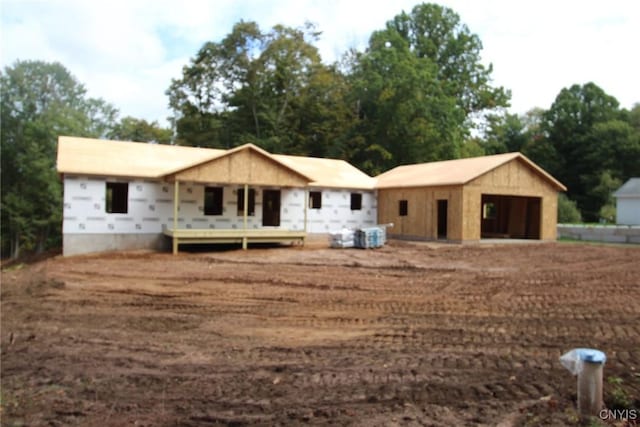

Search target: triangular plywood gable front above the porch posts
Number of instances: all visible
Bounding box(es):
[170,149,309,187]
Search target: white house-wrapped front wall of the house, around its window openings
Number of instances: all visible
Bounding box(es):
[62,175,377,255]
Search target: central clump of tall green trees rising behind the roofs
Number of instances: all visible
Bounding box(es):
[167,4,509,173]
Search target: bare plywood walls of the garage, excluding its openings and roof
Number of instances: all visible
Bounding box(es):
[378,158,558,241]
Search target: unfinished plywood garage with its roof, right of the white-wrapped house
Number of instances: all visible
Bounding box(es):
[376,153,566,242]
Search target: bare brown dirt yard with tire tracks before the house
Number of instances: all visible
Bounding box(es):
[1,242,640,426]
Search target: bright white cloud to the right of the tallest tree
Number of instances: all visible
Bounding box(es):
[450,0,640,113]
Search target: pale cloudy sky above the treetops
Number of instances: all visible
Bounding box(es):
[0,0,640,126]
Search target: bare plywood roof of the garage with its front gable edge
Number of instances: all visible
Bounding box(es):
[377,153,566,191]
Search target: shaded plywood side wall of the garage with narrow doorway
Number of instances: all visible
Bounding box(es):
[378,186,464,241]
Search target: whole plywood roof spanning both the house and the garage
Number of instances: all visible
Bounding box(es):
[57,136,566,191]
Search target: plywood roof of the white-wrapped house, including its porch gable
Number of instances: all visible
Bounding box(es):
[57,136,375,190]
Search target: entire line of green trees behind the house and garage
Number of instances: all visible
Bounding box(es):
[0,4,640,256]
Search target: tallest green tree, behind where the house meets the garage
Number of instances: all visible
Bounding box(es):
[350,4,509,173]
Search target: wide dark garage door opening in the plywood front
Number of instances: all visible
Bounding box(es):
[480,194,542,239]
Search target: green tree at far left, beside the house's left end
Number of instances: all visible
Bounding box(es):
[0,61,117,257]
